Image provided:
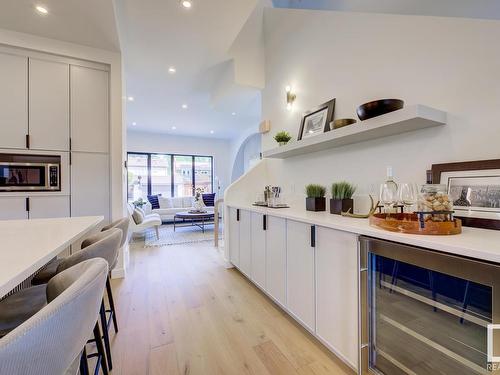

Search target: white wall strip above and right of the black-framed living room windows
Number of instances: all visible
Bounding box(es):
[127,131,231,197]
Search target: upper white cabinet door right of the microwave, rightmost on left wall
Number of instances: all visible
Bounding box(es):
[70,65,109,152]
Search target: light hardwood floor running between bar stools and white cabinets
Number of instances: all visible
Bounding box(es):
[110,238,354,375]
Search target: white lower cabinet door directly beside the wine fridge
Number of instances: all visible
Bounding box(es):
[316,227,358,368]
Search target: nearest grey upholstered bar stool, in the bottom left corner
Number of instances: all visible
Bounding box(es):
[0,259,108,375]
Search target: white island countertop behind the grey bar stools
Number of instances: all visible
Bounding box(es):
[0,216,104,298]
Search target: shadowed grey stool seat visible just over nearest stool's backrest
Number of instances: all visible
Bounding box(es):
[0,284,47,337]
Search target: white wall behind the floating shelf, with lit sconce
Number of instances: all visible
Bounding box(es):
[262,9,500,212]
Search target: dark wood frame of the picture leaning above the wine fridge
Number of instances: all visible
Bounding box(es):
[431,159,500,230]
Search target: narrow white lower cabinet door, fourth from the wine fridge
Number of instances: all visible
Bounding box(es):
[251,212,267,289]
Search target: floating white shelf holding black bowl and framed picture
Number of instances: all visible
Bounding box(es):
[263,104,446,159]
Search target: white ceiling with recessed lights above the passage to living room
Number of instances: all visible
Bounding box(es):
[116,0,260,138]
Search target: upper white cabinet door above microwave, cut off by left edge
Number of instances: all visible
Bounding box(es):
[0,53,28,148]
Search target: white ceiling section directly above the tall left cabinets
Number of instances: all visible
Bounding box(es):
[0,0,120,51]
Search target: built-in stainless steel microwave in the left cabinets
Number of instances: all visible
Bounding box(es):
[0,154,61,192]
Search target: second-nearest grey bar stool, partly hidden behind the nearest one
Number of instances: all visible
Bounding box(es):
[32,228,122,370]
